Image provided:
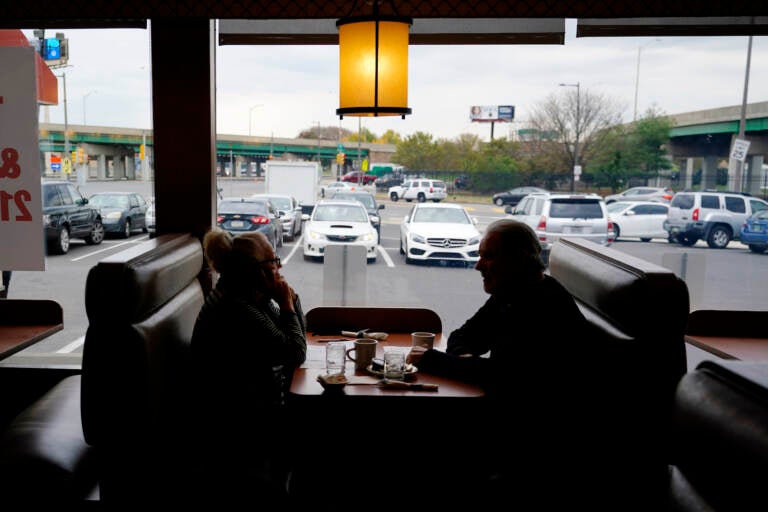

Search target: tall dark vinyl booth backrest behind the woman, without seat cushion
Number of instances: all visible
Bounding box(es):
[81,234,203,503]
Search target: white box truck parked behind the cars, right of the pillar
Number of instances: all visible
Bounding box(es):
[264,160,320,215]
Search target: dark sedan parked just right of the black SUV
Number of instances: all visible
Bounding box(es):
[88,192,149,238]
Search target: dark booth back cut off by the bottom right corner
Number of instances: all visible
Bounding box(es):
[668,360,768,512]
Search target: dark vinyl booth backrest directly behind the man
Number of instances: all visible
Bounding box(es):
[549,237,690,510]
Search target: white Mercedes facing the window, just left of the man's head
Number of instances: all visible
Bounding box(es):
[400,203,481,265]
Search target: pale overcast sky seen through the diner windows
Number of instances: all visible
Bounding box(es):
[24,20,768,140]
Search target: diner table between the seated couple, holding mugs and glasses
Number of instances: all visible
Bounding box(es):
[288,306,487,509]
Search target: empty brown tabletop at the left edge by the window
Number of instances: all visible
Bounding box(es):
[0,299,64,360]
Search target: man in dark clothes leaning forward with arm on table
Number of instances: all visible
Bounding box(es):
[408,219,608,510]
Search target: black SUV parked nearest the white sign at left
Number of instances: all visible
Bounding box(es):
[42,181,104,254]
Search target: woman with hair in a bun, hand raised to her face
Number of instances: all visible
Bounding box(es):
[191,230,307,503]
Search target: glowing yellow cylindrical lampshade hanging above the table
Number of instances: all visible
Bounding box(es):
[336,16,412,119]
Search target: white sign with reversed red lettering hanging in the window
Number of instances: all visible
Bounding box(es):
[0,46,45,270]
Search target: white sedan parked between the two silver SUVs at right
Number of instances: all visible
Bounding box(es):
[605,201,669,242]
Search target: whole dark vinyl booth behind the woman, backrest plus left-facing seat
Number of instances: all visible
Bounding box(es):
[0,234,207,508]
